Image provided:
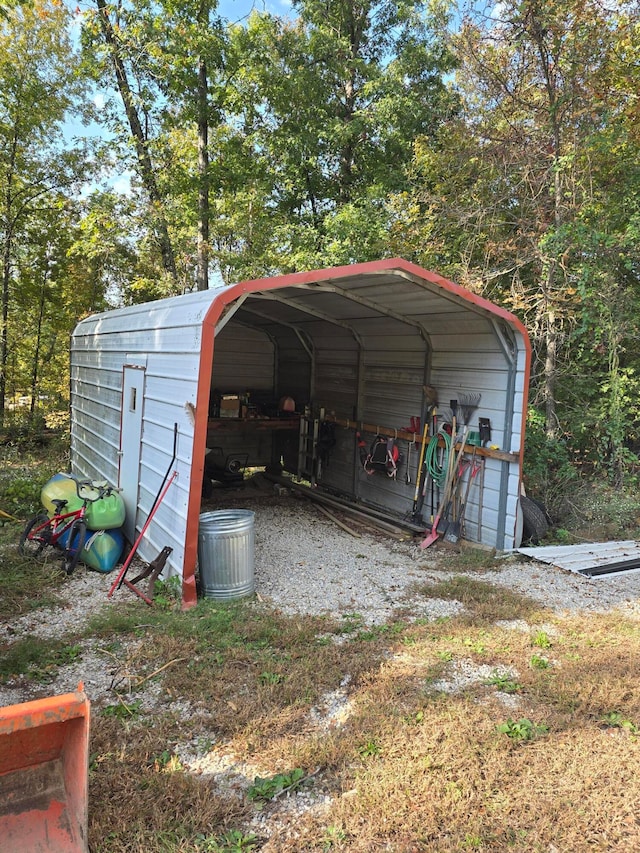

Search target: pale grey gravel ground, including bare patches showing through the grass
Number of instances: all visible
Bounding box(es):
[0,490,640,853]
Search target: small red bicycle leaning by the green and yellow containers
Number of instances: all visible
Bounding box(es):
[18,480,120,575]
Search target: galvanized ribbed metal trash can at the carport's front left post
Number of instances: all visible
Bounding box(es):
[198,509,255,601]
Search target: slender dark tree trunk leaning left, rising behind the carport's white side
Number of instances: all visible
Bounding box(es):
[96,0,178,282]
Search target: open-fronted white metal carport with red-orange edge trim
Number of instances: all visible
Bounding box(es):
[71,258,530,606]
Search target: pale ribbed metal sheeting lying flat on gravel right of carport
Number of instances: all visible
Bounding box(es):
[516,539,640,578]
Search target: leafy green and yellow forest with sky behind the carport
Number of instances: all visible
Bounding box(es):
[0,0,640,528]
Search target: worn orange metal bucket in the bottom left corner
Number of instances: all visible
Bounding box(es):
[0,684,89,853]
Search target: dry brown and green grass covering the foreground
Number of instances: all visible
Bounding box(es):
[0,442,640,853]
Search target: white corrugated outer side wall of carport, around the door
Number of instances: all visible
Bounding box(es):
[71,290,208,571]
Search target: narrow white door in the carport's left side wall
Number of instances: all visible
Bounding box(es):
[118,366,144,542]
